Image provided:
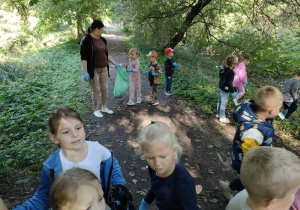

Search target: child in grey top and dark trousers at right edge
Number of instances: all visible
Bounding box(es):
[278,70,300,120]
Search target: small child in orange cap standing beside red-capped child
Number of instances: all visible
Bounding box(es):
[146,51,162,106]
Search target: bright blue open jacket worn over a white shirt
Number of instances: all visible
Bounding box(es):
[15,148,125,210]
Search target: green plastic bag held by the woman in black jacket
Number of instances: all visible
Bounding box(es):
[114,67,129,98]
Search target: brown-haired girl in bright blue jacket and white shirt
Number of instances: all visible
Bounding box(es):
[16,107,125,210]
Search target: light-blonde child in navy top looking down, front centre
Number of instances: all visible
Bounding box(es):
[139,121,198,210]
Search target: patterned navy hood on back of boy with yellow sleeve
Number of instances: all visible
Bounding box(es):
[233,99,273,127]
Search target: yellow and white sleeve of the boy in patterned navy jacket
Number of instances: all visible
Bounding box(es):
[241,128,264,155]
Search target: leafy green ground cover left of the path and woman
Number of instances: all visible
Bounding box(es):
[0,35,89,179]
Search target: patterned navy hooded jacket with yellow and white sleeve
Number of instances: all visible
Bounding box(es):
[231,99,274,170]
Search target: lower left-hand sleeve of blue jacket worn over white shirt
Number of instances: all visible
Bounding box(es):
[14,167,52,210]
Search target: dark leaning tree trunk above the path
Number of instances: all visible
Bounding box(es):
[163,0,212,49]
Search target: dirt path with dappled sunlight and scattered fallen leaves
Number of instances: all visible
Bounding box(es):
[85,31,236,209]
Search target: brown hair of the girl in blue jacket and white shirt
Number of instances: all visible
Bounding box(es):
[48,106,83,136]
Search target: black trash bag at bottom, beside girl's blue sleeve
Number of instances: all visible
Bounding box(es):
[107,184,137,210]
